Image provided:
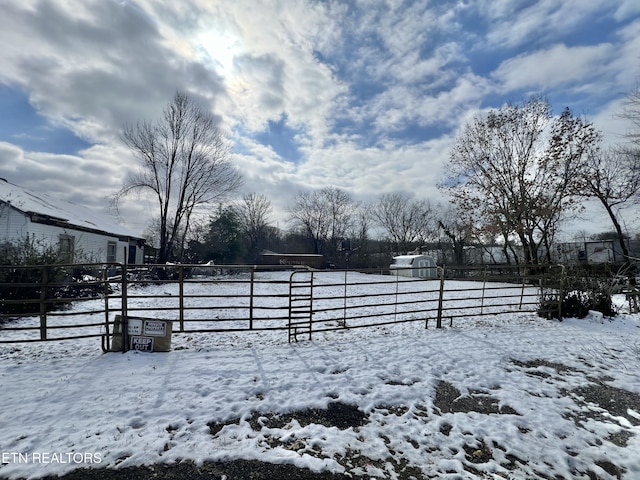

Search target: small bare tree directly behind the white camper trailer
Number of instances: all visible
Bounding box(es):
[372,193,436,253]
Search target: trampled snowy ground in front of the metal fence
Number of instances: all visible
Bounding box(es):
[0,272,640,479]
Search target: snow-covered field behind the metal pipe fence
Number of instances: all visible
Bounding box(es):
[0,270,539,340]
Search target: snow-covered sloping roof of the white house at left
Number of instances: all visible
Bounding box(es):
[0,178,142,239]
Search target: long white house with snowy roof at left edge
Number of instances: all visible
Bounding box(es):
[0,178,144,264]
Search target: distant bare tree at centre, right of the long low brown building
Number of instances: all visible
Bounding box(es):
[288,187,359,259]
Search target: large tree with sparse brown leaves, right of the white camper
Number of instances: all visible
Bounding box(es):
[441,98,600,264]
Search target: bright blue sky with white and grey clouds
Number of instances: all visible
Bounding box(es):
[0,0,640,238]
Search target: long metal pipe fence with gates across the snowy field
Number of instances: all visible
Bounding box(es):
[0,264,563,350]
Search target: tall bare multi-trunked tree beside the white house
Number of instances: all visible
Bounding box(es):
[116,92,241,263]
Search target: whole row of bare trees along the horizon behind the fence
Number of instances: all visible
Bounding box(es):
[115,91,640,267]
